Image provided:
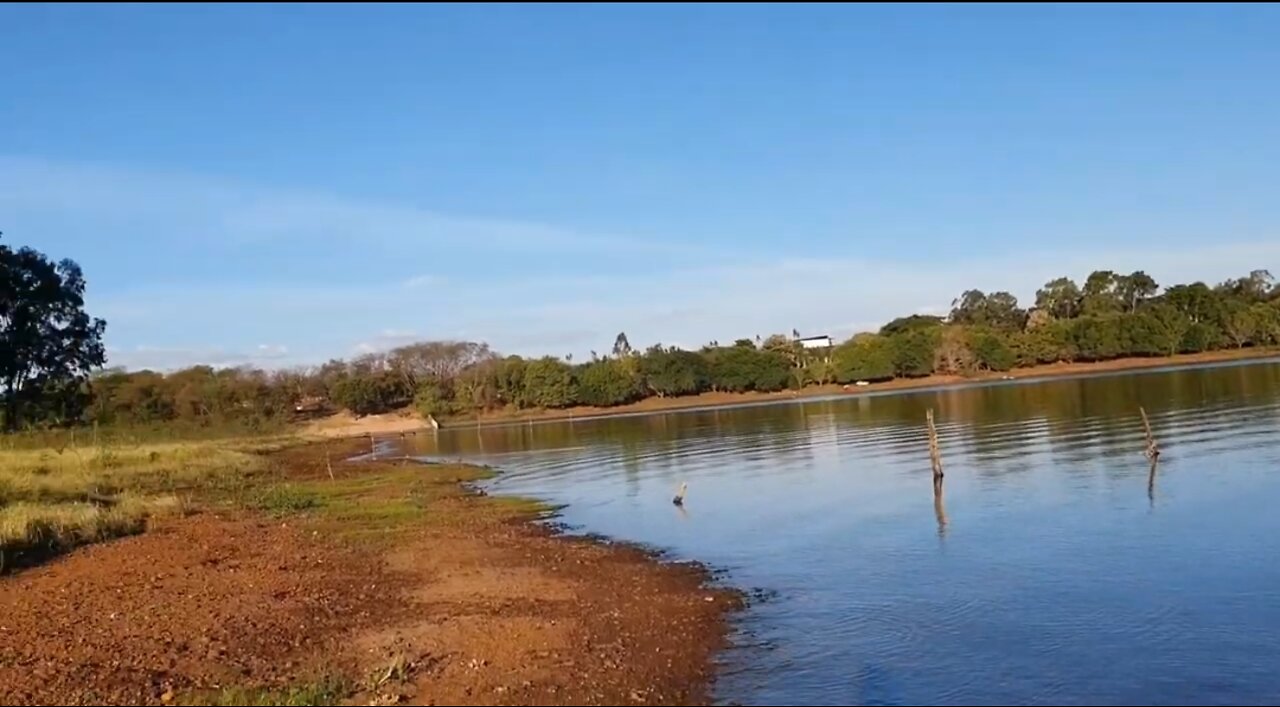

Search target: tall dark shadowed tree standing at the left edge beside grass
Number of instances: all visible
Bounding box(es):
[0,234,106,430]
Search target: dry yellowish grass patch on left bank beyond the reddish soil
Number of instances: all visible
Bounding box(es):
[0,438,292,571]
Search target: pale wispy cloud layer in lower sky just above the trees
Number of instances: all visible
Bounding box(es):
[0,158,1280,366]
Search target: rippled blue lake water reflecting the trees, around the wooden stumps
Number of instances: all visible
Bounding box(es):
[407,362,1280,704]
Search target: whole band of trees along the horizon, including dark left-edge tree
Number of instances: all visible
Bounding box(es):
[0,234,1280,429]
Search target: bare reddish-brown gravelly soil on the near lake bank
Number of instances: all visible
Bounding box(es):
[0,438,739,704]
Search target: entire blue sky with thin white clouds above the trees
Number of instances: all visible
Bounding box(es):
[0,5,1280,368]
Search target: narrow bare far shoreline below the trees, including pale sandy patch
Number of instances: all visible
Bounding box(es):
[307,348,1280,437]
